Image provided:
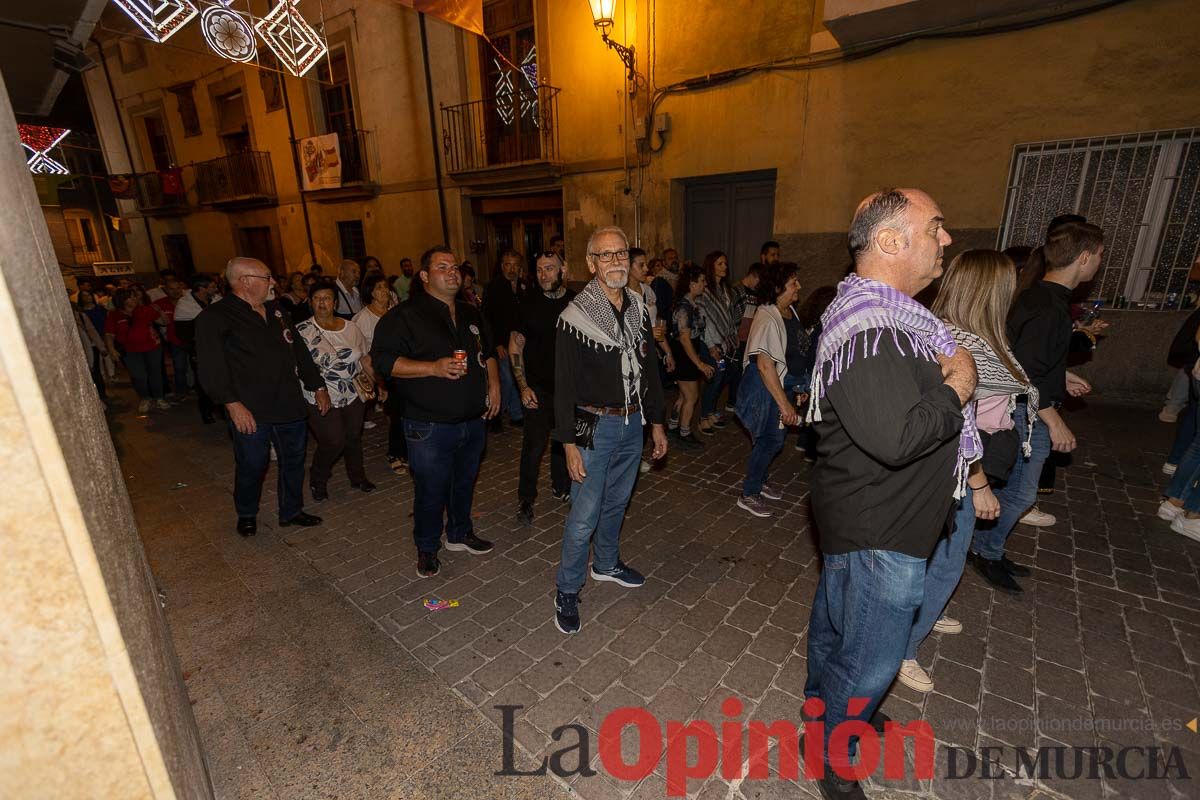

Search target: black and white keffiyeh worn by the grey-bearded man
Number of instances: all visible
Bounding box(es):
[558,278,648,425]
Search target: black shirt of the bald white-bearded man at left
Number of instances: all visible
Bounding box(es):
[196,295,325,422]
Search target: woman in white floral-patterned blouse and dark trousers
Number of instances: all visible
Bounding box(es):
[296,282,374,501]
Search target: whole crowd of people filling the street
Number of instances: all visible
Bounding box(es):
[73,183,1171,799]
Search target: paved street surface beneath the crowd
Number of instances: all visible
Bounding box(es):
[121,386,1200,800]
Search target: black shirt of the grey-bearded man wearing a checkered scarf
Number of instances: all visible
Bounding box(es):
[552,284,662,443]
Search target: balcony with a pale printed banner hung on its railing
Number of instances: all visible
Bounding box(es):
[295,131,379,203]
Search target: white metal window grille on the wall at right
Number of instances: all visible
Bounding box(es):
[998,128,1200,311]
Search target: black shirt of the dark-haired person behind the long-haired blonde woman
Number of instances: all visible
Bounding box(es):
[1008,281,1072,408]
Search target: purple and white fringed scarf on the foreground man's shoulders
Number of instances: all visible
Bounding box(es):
[808,272,983,499]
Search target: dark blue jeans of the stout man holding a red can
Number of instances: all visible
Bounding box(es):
[404,419,487,553]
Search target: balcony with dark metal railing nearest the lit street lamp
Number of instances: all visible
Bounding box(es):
[442,85,559,182]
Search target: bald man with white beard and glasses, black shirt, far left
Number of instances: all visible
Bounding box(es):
[196,257,330,536]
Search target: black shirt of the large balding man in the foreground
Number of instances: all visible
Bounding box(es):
[809,331,962,558]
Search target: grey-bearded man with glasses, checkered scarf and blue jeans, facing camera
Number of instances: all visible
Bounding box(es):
[553,228,667,633]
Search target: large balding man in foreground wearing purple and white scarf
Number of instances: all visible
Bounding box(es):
[804,190,983,800]
